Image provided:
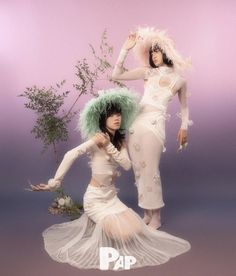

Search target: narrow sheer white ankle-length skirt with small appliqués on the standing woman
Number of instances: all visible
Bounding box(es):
[128,111,167,209]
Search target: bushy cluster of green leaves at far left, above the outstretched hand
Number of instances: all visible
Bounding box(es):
[19,80,76,151]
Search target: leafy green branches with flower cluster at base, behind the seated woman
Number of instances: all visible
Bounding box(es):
[19,30,125,219]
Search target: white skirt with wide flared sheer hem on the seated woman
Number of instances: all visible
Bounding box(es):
[43,185,190,269]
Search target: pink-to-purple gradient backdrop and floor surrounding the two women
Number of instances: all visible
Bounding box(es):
[0,0,236,276]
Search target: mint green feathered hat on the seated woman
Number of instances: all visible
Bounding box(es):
[76,87,139,139]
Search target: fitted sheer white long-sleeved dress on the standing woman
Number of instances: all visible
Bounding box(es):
[112,49,192,209]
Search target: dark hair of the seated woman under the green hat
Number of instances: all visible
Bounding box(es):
[99,103,125,150]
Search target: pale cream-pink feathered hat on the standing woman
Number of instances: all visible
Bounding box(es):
[133,27,191,71]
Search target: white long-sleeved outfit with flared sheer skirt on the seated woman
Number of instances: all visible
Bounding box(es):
[43,140,190,269]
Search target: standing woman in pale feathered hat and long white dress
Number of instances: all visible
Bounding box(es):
[112,28,192,229]
